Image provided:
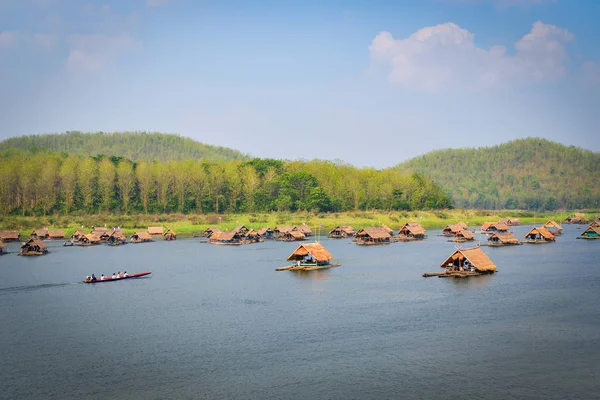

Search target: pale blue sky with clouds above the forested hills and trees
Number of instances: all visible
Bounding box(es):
[0,0,600,168]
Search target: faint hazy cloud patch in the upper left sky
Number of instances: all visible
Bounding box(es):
[67,35,141,72]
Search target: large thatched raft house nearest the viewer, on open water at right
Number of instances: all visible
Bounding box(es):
[423,247,497,278]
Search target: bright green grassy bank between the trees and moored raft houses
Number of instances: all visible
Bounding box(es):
[0,209,600,236]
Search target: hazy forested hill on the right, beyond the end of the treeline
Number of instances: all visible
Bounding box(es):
[396,138,600,210]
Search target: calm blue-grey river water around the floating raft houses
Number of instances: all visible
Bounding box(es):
[0,225,600,399]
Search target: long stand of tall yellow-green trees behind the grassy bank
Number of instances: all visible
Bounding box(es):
[0,150,451,215]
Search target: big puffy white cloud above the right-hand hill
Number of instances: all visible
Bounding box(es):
[369,22,574,90]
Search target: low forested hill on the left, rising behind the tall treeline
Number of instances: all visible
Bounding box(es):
[0,131,249,161]
